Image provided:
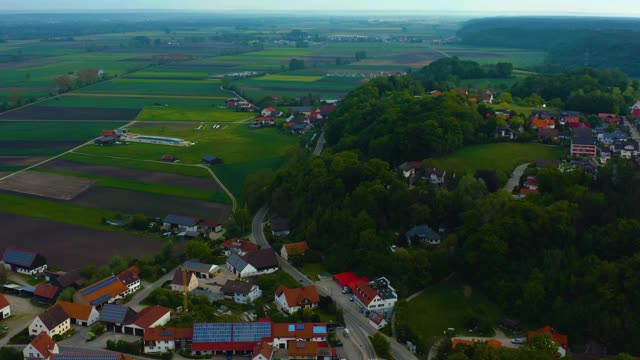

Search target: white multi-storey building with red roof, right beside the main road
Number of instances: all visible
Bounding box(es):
[353,277,398,318]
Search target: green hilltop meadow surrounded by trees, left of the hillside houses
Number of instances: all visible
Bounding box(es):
[433,143,564,173]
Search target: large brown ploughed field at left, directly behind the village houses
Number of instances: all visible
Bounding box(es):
[0,211,164,271]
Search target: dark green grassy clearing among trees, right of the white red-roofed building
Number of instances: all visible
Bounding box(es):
[407,281,502,343]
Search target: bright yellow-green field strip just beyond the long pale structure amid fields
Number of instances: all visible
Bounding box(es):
[136,107,255,122]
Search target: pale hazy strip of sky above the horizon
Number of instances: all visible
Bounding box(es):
[0,0,640,16]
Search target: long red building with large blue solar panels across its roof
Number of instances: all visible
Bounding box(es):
[191,322,272,355]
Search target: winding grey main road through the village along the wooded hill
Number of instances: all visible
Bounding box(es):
[251,206,416,360]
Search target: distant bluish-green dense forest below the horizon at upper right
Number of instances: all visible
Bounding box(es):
[458,17,640,76]
